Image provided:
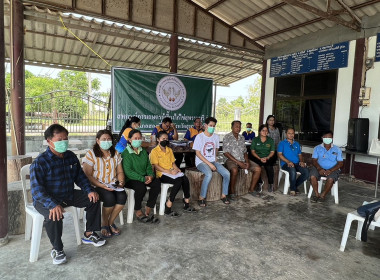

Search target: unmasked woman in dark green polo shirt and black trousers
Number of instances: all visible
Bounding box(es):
[251,124,276,192]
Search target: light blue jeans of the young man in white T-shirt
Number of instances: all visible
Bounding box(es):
[197,162,230,198]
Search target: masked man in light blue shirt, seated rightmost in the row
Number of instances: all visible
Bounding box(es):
[310,131,343,202]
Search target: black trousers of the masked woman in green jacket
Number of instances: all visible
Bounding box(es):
[126,178,161,211]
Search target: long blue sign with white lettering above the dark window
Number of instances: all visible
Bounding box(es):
[270,41,348,77]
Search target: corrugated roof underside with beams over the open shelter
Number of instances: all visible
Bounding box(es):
[4,0,380,84]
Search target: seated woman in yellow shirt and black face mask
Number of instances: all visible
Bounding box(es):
[150,131,195,217]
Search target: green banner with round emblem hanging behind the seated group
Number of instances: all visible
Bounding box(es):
[111,67,213,133]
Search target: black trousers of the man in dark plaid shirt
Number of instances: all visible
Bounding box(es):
[34,190,100,251]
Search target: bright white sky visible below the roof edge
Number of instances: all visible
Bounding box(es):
[5,63,258,101]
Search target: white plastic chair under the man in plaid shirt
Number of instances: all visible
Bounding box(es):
[20,164,82,262]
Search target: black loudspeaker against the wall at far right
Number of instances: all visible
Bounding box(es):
[347,118,369,153]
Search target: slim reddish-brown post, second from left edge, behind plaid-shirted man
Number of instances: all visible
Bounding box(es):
[11,0,25,155]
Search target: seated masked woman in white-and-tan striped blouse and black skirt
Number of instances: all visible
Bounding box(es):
[83,130,127,238]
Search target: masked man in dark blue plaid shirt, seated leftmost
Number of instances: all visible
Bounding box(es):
[30,124,105,264]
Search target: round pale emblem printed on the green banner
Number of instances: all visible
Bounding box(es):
[156,76,186,111]
